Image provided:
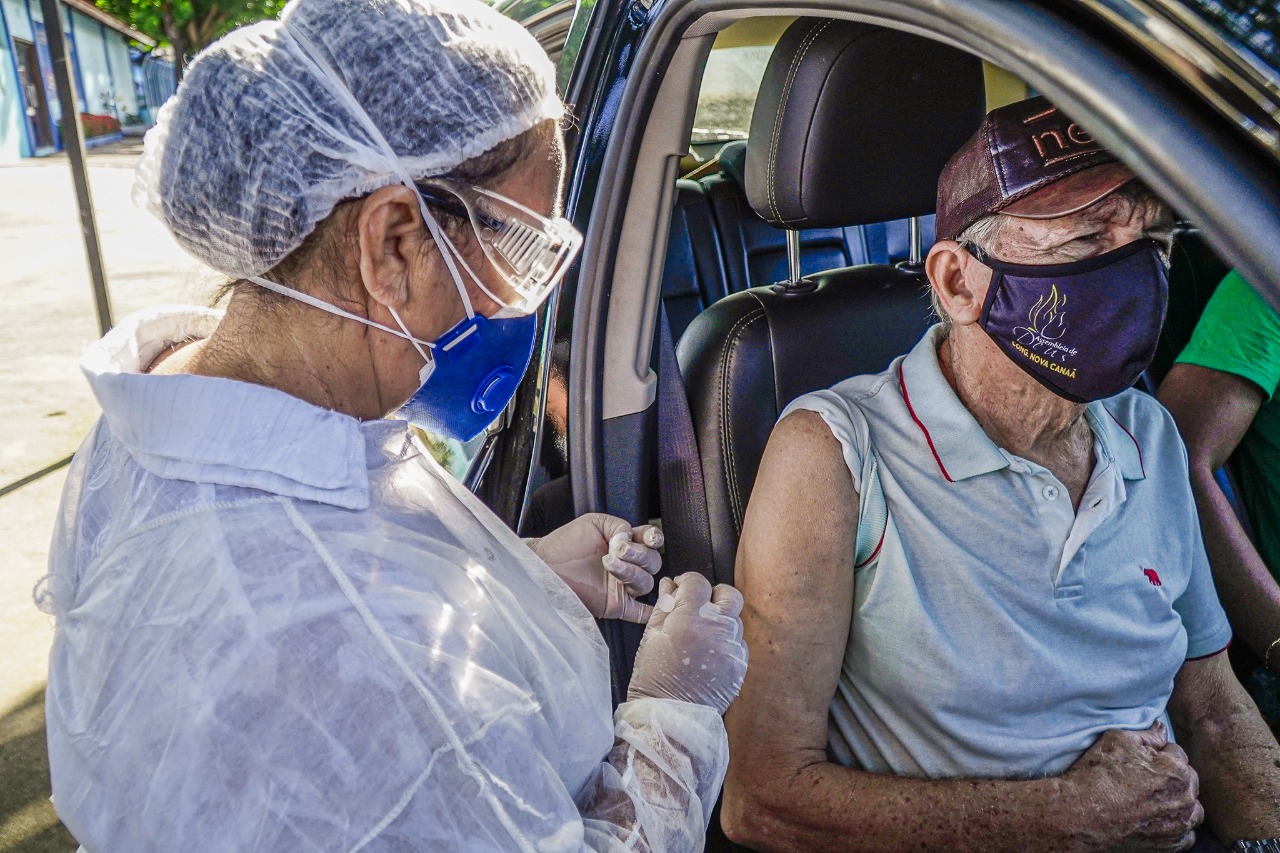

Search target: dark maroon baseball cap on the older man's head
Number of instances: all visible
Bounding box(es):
[936,97,1134,240]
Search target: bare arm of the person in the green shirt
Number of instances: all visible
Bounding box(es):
[1160,364,1280,672]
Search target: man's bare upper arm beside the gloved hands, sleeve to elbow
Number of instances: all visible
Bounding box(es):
[726,411,858,795]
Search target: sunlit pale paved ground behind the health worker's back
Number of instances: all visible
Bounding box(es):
[0,142,218,853]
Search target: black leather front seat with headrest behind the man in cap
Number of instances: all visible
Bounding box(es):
[677,18,986,583]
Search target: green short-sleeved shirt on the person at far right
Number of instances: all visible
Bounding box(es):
[1178,270,1280,580]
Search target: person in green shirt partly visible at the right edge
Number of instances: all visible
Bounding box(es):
[1158,272,1280,731]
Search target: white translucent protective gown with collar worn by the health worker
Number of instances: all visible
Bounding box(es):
[38,309,728,853]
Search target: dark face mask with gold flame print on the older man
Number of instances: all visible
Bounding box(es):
[965,238,1169,403]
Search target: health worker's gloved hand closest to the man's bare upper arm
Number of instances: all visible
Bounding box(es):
[627,573,746,713]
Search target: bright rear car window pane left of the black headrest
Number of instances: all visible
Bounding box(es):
[692,45,773,145]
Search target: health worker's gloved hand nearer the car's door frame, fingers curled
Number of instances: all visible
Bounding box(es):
[526,512,663,622]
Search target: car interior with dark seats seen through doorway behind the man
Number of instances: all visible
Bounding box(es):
[521,8,1259,694]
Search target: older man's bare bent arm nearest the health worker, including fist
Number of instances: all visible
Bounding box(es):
[722,411,1202,853]
